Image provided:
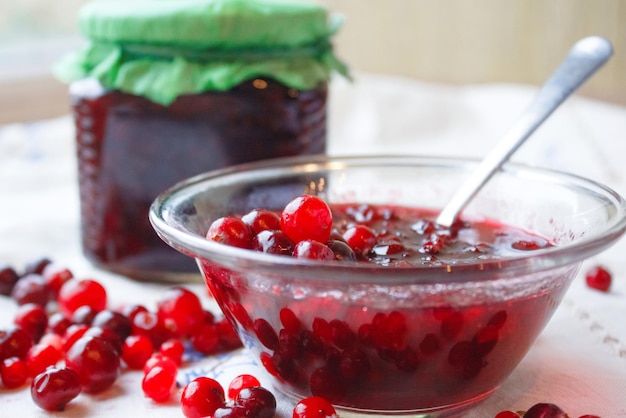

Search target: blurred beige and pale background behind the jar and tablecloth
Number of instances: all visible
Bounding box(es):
[0,0,626,123]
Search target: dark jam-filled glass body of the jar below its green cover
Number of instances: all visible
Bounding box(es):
[72,79,327,280]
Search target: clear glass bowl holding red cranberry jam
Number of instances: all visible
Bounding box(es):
[150,156,626,417]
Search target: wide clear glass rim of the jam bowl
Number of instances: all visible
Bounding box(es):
[148,155,626,285]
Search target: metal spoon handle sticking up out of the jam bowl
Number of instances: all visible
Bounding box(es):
[436,36,613,228]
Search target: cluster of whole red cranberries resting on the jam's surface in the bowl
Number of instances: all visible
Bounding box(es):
[206,195,450,261]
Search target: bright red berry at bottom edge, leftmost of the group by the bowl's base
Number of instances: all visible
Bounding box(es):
[180,377,225,418]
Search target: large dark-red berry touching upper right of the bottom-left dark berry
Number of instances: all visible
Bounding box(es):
[65,336,120,393]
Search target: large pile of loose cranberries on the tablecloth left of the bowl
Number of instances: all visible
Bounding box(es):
[0,259,241,411]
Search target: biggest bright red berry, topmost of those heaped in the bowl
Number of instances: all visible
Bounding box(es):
[280,195,333,244]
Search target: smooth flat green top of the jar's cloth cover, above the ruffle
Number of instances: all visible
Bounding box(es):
[79,0,328,49]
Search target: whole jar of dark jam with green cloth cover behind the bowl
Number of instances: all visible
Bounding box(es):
[55,0,347,281]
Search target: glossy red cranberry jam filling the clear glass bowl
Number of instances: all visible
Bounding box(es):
[200,205,577,412]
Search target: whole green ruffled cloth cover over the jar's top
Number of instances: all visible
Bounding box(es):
[54,0,348,104]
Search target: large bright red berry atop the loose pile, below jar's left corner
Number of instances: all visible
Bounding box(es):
[58,279,107,318]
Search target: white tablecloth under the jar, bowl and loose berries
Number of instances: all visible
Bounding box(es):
[0,74,626,418]
